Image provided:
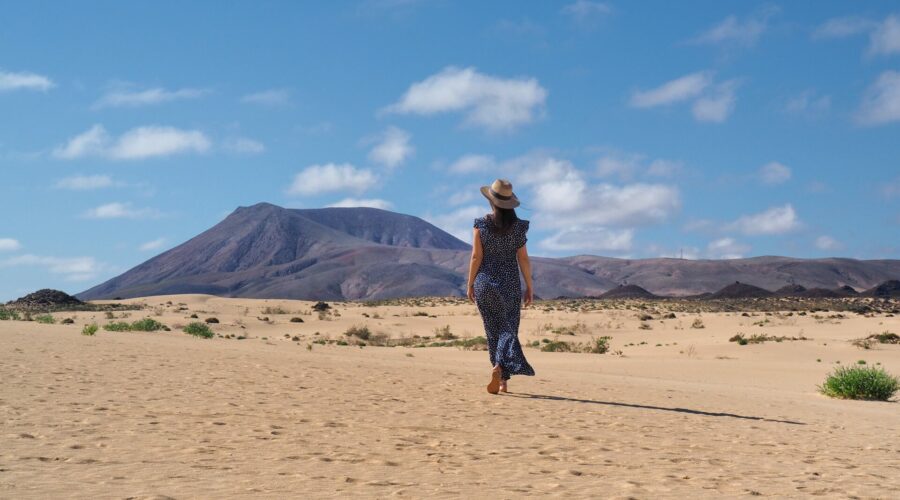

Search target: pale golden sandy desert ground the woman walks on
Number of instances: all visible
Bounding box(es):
[0,295,900,499]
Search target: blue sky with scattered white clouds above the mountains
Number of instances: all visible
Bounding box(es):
[0,0,900,300]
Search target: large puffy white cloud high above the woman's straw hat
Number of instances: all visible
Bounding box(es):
[385,66,547,131]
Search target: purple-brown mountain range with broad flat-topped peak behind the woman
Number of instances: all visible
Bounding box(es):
[76,203,900,300]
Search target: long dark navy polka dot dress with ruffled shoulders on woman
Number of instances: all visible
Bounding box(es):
[475,216,534,380]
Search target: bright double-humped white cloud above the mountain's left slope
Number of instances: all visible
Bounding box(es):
[53,125,210,160]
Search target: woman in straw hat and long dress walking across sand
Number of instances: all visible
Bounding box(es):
[467,179,534,394]
